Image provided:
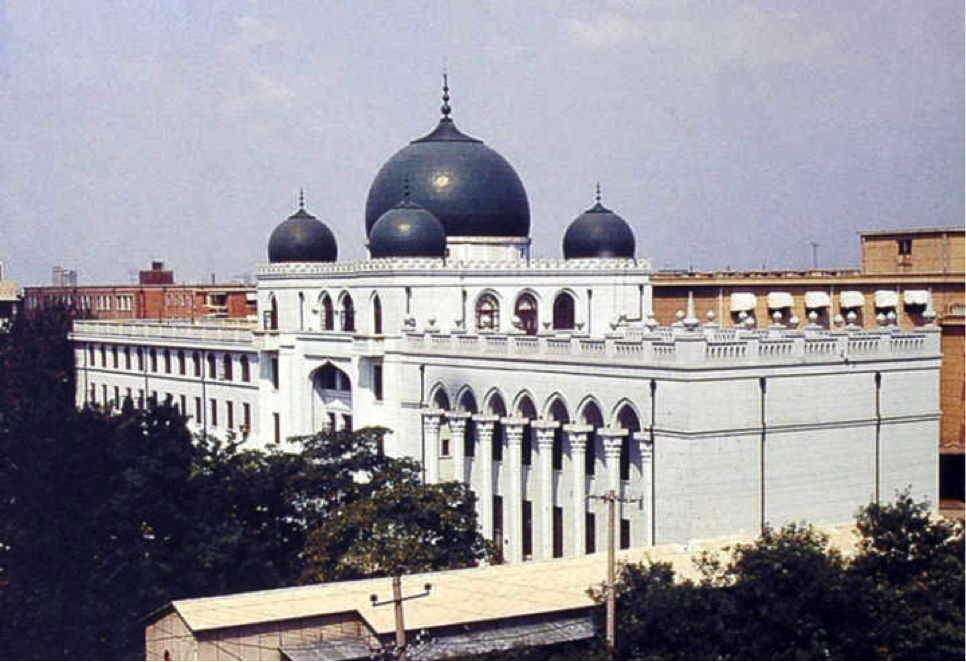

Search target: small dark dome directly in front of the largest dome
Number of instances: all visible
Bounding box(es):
[369,200,446,257]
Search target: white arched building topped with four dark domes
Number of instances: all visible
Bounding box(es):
[72,80,941,562]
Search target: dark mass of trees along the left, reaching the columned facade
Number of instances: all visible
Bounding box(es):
[0,308,492,660]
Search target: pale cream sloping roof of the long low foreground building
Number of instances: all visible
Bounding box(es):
[168,523,858,634]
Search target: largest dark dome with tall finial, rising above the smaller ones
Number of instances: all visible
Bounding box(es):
[366,80,530,237]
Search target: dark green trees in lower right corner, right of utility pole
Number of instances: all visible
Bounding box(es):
[594,493,966,660]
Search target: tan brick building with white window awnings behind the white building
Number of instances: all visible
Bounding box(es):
[653,227,966,500]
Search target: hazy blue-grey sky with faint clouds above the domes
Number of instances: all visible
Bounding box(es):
[0,0,966,285]
